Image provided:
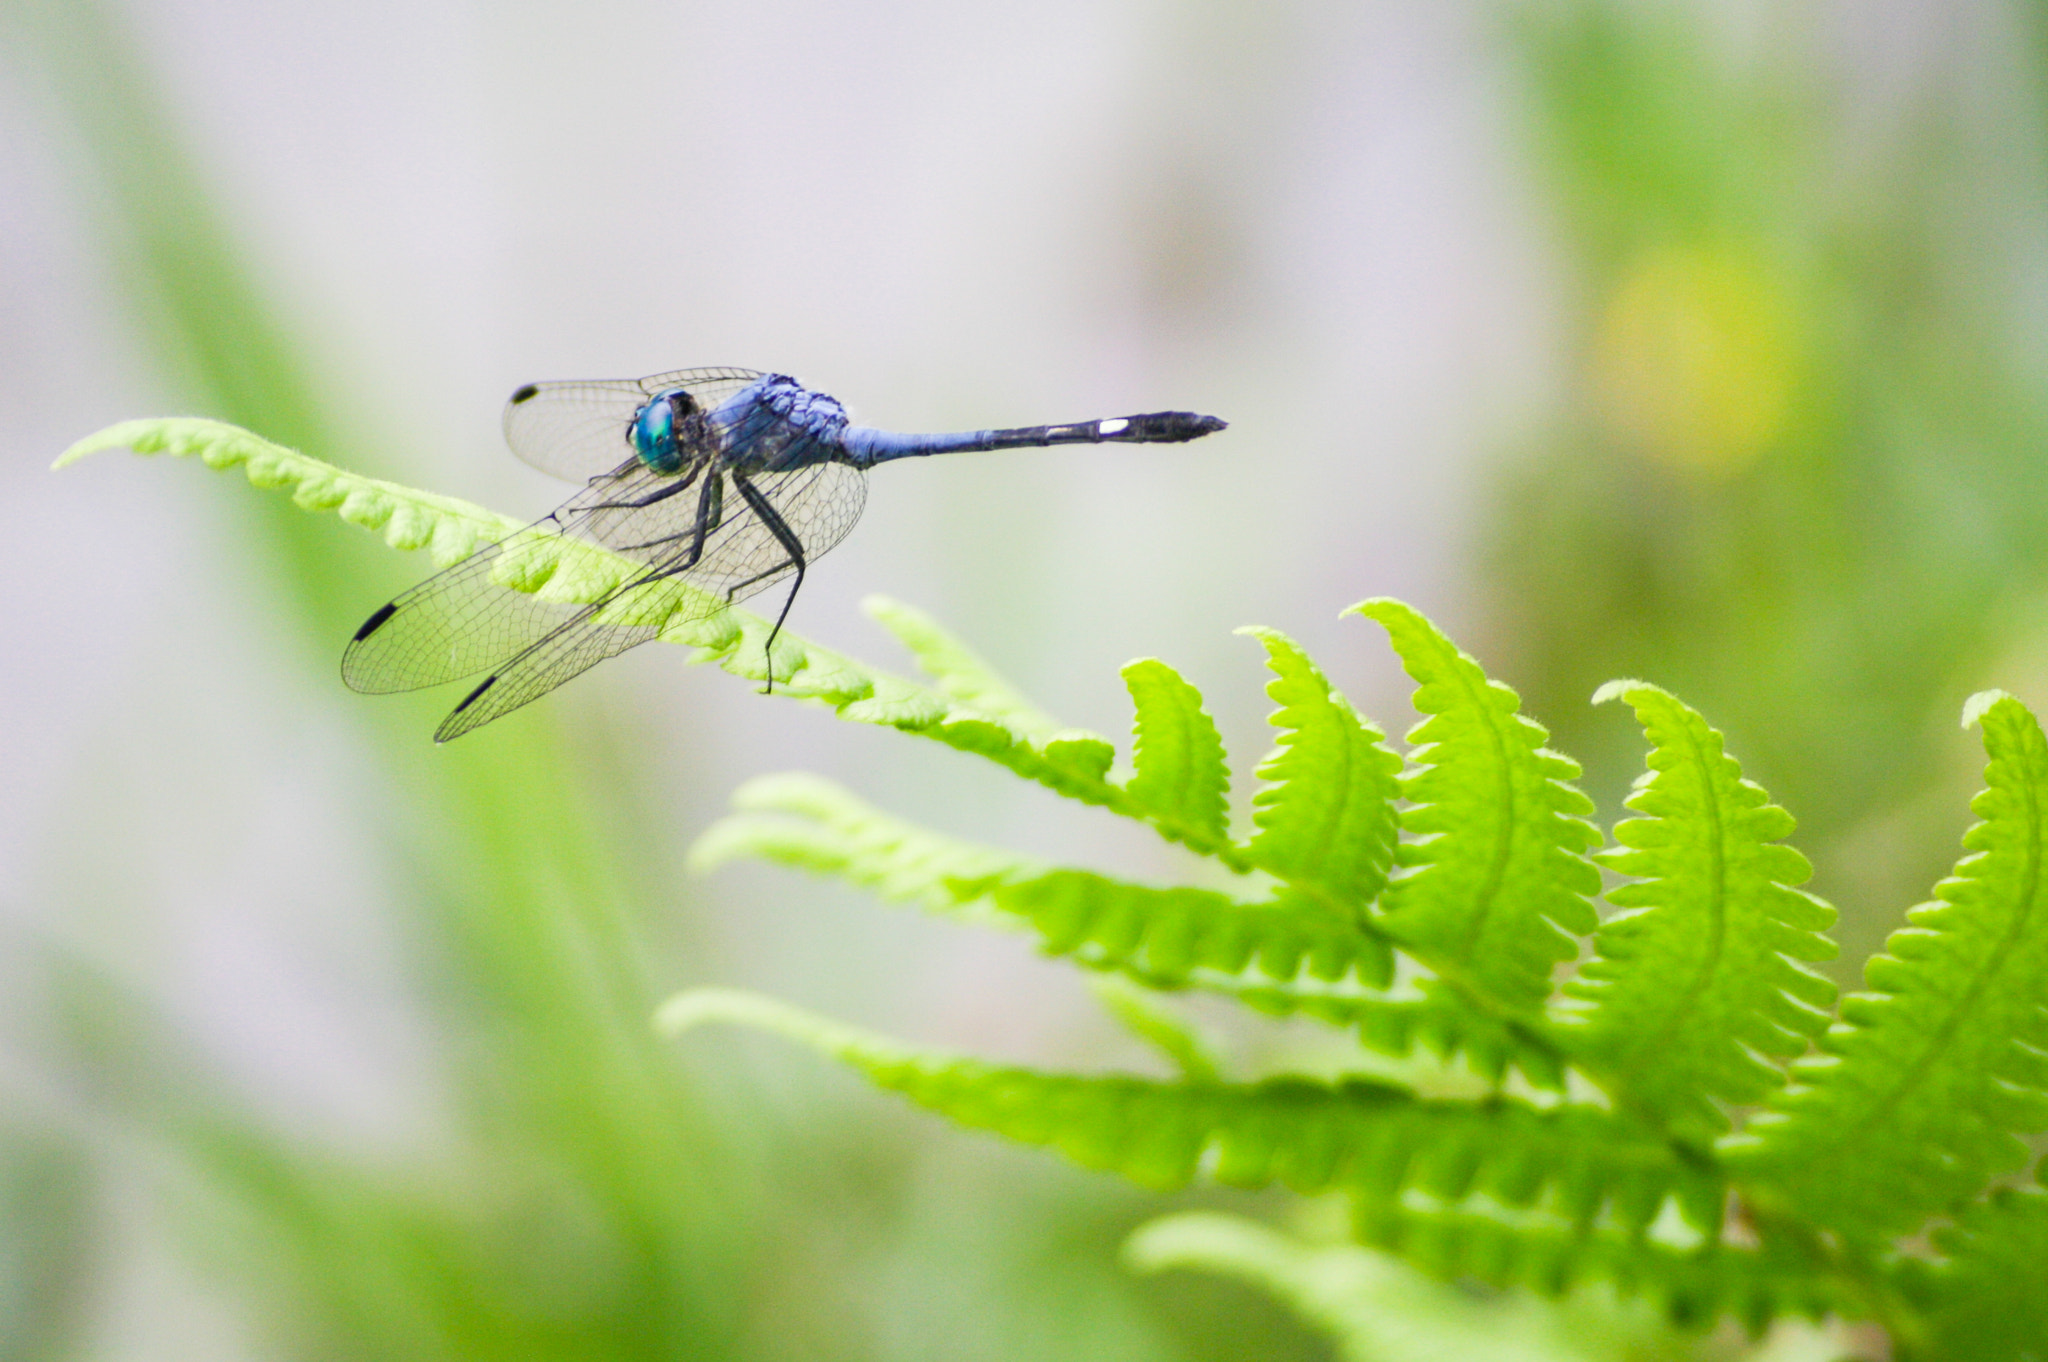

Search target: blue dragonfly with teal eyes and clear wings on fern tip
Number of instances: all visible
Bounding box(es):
[342,369,1227,743]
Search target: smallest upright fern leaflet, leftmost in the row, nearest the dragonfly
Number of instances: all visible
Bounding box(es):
[1124,657,1231,850]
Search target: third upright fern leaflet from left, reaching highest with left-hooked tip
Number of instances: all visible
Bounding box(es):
[1352,598,1599,1077]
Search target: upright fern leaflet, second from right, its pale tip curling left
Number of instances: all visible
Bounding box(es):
[1567,682,1835,1135]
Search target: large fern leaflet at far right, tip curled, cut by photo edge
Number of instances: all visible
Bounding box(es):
[1726,692,2048,1241]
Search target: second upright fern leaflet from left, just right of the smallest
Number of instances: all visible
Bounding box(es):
[1239,627,1401,911]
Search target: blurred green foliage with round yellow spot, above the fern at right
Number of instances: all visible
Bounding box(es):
[1483,0,2048,956]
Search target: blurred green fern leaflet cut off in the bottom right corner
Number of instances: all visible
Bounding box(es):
[1898,1184,2048,1362]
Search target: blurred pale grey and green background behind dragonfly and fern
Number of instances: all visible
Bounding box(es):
[0,0,2048,1360]
